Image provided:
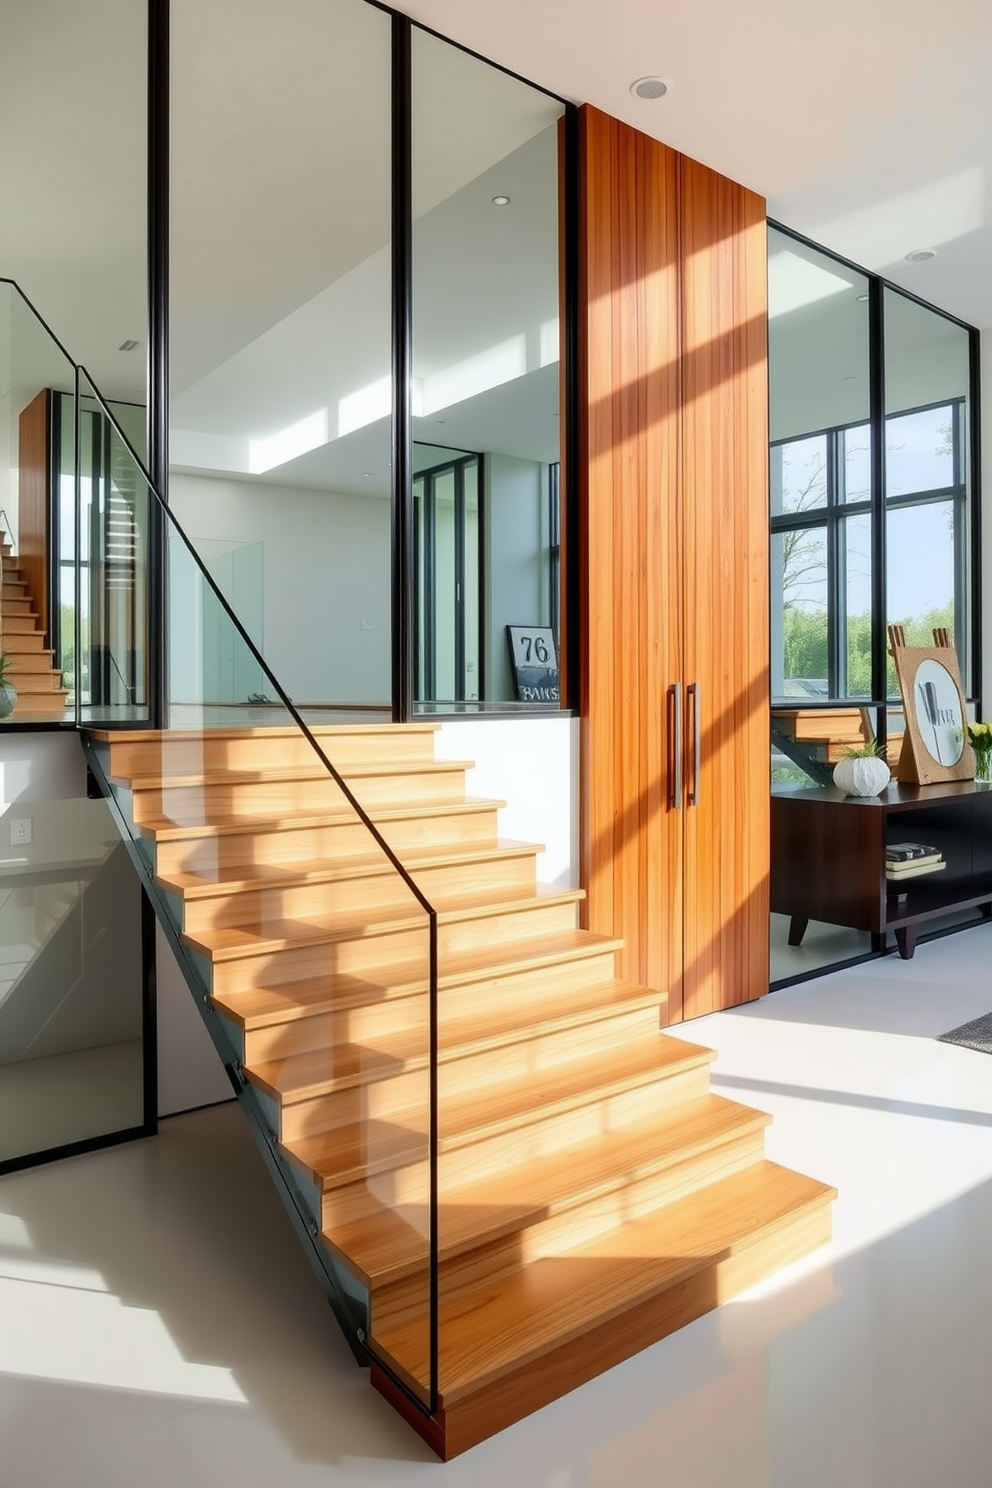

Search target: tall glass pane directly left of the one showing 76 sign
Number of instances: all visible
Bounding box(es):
[170,0,393,719]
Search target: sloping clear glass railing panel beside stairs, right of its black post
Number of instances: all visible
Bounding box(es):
[77,369,437,1412]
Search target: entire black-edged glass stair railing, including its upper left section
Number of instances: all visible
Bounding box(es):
[0,283,439,1414]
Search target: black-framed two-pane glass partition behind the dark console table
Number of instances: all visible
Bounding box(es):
[769,228,979,982]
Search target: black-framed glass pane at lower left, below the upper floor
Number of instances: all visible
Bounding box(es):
[0,799,146,1164]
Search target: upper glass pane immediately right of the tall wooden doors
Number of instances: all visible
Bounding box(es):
[769,228,872,705]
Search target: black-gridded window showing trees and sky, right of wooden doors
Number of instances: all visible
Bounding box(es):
[770,399,968,699]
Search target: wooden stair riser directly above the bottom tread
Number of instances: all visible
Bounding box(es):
[368,1131,764,1336]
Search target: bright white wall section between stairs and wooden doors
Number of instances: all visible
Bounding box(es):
[434,713,579,888]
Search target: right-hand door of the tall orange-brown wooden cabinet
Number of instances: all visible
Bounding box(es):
[680,158,770,1018]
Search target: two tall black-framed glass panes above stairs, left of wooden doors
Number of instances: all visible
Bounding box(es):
[170,0,564,717]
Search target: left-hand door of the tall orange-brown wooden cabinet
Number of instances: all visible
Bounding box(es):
[577,107,683,1010]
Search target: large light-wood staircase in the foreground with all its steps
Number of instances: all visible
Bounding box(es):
[92,725,834,1458]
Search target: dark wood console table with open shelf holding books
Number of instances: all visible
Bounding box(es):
[772,780,992,958]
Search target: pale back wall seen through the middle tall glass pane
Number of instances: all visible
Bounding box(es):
[170,473,390,704]
